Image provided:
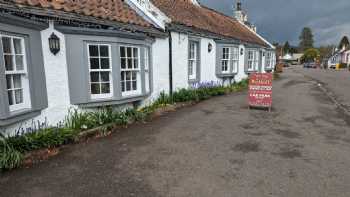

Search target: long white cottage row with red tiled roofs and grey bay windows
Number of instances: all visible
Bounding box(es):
[0,0,276,132]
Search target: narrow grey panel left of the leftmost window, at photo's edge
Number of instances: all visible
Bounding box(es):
[0,39,9,119]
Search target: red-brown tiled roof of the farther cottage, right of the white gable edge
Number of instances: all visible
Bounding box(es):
[151,0,267,46]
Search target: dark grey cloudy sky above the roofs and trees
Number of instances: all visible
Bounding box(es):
[199,0,350,46]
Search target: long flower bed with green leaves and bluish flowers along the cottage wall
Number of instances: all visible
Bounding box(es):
[0,80,248,170]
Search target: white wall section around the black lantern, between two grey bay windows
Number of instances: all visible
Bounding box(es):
[6,24,72,134]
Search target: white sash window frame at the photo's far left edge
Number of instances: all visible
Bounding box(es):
[0,34,31,112]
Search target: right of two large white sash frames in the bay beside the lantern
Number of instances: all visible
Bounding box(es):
[119,45,142,97]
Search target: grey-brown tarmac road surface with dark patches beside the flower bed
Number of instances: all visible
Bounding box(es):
[0,68,350,197]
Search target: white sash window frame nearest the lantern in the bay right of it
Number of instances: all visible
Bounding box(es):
[87,43,113,99]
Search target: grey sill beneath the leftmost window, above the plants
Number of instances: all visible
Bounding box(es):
[0,109,41,127]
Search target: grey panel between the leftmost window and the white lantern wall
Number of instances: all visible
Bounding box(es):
[25,32,48,111]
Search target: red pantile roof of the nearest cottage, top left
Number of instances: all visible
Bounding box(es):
[4,0,151,27]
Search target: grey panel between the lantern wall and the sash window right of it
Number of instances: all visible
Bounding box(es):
[66,36,90,104]
